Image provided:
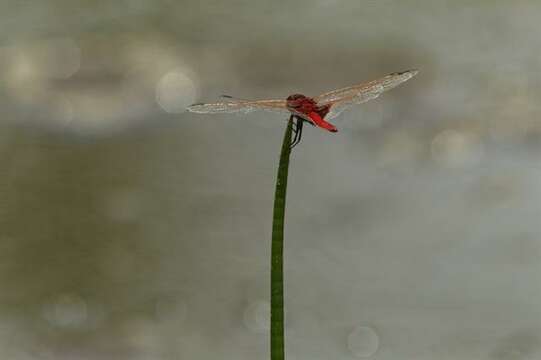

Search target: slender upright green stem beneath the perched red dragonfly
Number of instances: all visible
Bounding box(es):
[270,119,293,360]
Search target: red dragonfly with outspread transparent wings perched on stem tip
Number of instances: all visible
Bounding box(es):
[187,70,419,148]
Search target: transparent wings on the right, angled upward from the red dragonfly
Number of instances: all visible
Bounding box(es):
[314,70,419,119]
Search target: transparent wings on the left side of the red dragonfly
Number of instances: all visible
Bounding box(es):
[187,97,289,114]
